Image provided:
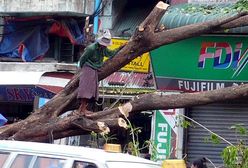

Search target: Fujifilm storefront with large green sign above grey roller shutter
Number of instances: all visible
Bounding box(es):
[151,35,248,165]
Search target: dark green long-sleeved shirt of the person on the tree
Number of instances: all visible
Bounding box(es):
[79,42,118,69]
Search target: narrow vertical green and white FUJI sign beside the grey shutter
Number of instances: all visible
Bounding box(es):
[152,109,180,161]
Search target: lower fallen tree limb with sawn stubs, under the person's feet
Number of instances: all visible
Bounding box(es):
[13,84,248,141]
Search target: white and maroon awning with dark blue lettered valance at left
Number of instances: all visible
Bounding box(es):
[0,71,73,103]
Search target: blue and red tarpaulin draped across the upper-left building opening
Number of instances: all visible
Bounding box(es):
[0,18,84,62]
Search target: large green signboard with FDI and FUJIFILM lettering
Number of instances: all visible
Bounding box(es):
[151,36,248,92]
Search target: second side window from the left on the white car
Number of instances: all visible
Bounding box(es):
[11,155,33,168]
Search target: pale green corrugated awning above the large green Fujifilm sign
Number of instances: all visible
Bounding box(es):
[161,3,248,33]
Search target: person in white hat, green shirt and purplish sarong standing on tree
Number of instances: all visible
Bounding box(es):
[77,30,122,115]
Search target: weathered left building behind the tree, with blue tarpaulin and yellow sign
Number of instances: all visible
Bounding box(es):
[0,0,154,156]
